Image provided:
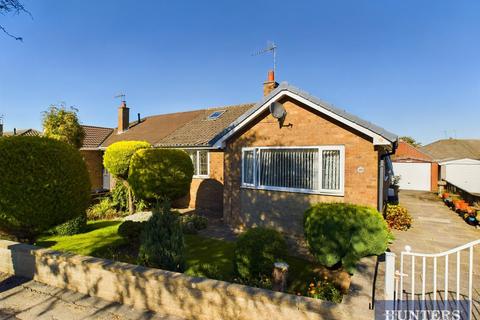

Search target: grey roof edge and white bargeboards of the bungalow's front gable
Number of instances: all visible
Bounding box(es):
[214,82,398,148]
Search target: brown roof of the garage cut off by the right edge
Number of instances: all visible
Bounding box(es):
[420,139,480,161]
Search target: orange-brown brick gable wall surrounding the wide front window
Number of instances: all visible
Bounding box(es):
[224,100,379,233]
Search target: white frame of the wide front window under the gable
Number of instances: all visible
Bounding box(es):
[241,145,345,196]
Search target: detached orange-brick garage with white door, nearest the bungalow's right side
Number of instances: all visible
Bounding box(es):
[391,140,438,192]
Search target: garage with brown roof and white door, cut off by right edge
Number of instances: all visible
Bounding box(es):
[421,139,480,197]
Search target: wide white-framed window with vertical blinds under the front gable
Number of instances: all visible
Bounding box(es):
[242,146,345,195]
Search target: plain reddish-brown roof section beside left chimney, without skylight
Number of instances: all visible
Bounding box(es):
[101,110,203,147]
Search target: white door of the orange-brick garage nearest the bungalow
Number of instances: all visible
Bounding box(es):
[393,162,431,191]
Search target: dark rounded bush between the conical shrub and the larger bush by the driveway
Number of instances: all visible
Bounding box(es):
[233,228,287,281]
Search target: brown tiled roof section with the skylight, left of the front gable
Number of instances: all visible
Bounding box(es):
[156,103,255,147]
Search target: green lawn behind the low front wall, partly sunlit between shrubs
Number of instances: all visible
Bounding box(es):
[36,221,314,292]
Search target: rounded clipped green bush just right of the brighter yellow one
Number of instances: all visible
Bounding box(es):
[128,149,193,202]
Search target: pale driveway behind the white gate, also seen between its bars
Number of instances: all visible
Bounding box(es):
[376,191,480,319]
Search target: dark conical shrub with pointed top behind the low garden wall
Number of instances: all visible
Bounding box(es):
[138,201,185,272]
